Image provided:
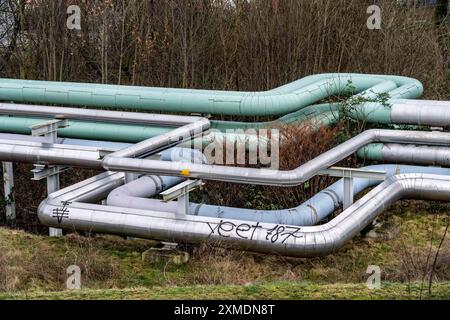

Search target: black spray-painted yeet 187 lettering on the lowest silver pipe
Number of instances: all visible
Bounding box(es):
[207,220,303,243]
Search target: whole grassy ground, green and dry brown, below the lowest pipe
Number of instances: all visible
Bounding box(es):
[0,201,450,299]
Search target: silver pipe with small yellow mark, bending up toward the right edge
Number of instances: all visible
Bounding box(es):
[103,129,450,186]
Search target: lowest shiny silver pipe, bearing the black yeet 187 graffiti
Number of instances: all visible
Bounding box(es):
[38,173,450,257]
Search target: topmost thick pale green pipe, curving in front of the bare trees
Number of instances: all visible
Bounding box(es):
[0,73,423,116]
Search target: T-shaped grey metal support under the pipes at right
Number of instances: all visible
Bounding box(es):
[319,167,386,210]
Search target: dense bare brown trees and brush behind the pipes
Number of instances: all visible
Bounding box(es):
[0,0,450,97]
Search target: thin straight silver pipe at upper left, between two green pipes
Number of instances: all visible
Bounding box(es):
[0,103,201,127]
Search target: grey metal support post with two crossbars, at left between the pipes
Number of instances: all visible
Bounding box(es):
[31,119,69,237]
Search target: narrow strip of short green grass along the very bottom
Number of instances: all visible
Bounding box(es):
[0,282,450,300]
